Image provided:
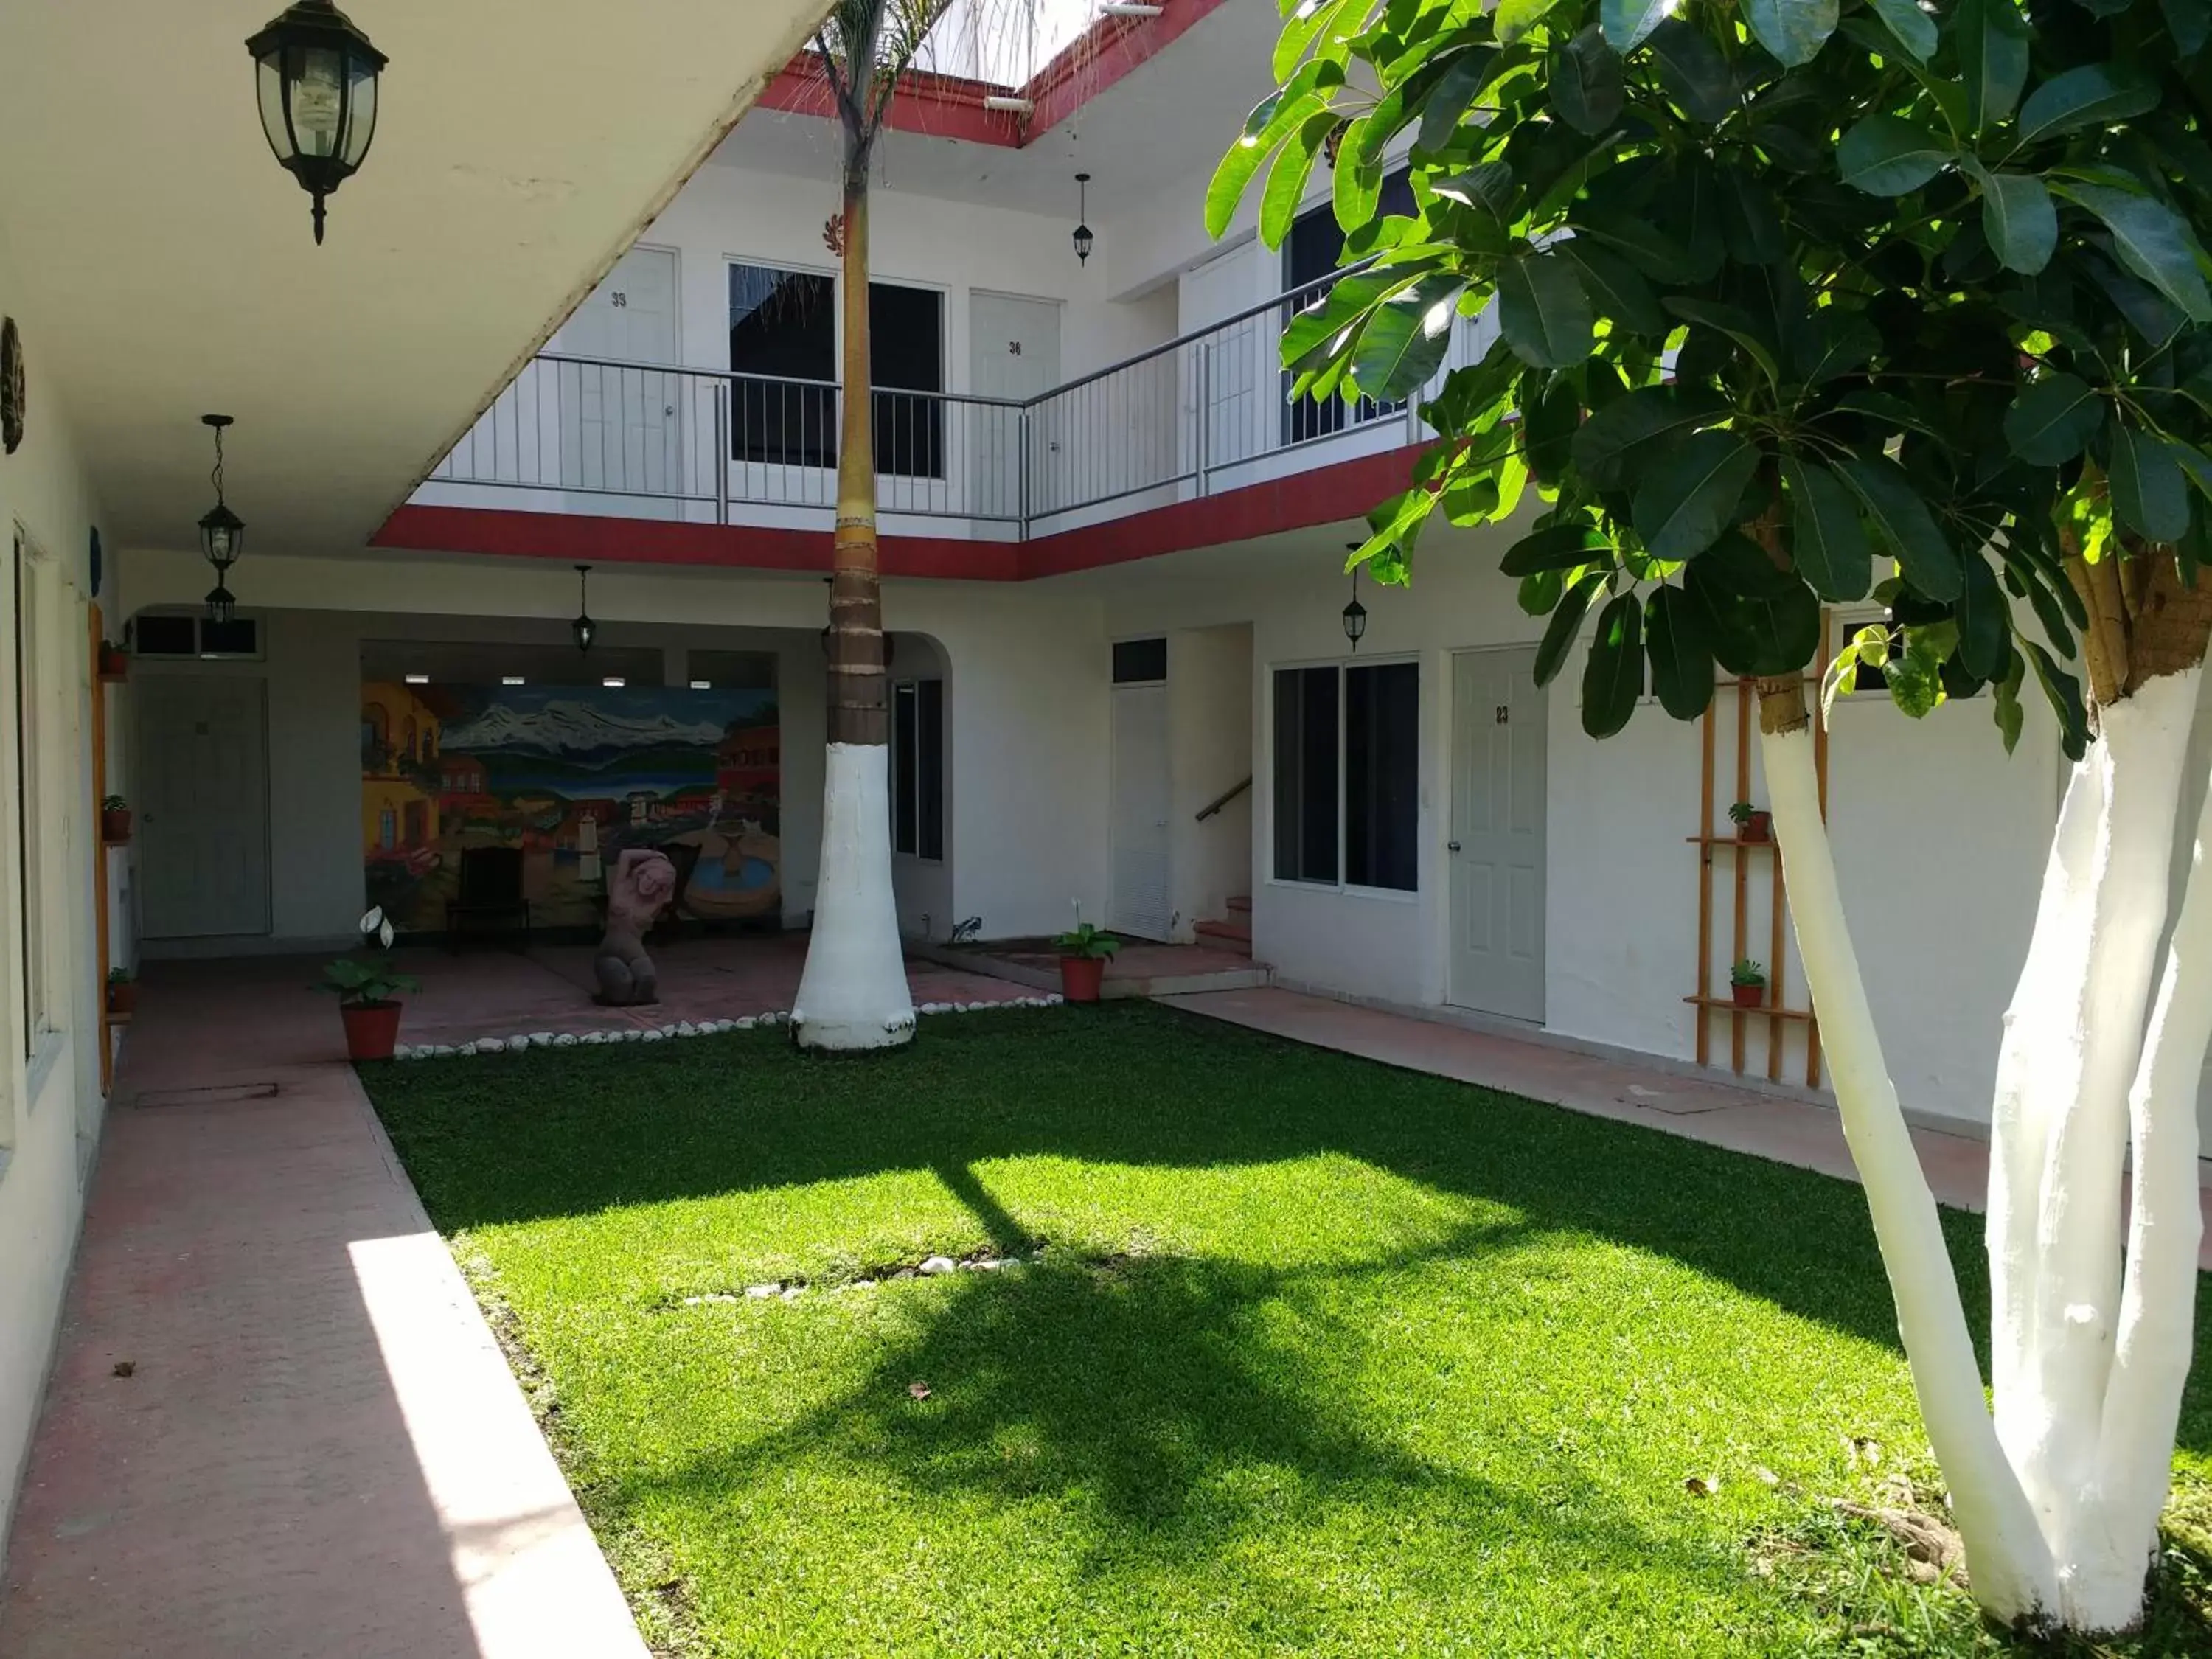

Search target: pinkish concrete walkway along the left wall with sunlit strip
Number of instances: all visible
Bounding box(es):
[0,962,646,1659]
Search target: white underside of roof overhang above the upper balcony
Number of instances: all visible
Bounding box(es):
[714,0,1281,226]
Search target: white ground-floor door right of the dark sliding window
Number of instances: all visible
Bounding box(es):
[1449,648,1544,1022]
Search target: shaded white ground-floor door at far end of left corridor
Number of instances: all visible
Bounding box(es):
[135,675,270,938]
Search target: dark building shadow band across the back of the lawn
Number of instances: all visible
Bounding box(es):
[367,1002,2212,1451]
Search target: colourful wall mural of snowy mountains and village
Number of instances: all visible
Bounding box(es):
[361,681,783,931]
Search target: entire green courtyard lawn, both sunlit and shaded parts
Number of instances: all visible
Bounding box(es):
[367,1002,2212,1657]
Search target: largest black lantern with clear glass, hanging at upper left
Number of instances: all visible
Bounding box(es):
[246,0,387,241]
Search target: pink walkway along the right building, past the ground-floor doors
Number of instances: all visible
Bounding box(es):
[1161,987,2212,1270]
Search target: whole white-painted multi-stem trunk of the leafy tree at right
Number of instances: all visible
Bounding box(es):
[1761,670,2212,1630]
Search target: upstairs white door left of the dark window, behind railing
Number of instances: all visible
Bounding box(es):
[557,248,686,495]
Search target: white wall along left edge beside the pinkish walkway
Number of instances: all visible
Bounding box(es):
[0,248,119,1537]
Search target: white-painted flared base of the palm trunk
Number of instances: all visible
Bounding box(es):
[792,743,914,1048]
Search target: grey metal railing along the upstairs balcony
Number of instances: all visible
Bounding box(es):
[429,272,1495,538]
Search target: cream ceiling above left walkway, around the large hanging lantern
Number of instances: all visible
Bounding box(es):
[0,0,827,557]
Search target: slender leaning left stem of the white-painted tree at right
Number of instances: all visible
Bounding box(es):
[1761,728,2057,1619]
